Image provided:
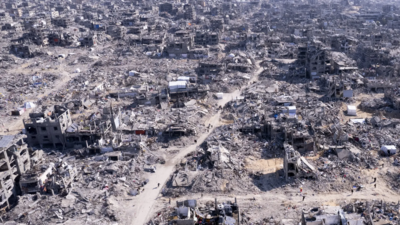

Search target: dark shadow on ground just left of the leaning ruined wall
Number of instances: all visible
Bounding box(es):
[249,169,287,192]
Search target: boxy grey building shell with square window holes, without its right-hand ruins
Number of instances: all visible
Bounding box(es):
[23,106,72,147]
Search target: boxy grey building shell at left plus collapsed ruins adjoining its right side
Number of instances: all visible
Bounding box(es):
[24,105,121,148]
